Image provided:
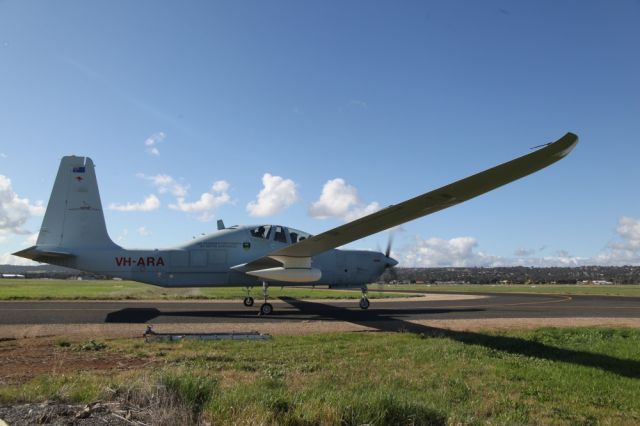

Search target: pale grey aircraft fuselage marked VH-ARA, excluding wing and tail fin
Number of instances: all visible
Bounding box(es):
[50,227,386,287]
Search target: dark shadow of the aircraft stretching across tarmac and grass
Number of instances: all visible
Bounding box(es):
[105,297,640,379]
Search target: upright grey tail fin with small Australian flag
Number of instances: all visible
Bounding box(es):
[36,156,117,250]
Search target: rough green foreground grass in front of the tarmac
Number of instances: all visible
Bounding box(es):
[0,328,640,425]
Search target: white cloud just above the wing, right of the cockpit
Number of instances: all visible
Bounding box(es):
[309,178,380,222]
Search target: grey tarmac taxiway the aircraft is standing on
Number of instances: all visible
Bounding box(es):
[0,293,640,327]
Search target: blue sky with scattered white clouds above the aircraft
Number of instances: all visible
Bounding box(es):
[0,0,640,266]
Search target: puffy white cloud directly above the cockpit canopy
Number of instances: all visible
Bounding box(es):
[247,173,298,217]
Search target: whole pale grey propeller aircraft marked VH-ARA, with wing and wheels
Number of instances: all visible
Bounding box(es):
[14,133,578,315]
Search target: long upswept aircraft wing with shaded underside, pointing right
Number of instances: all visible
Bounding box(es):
[269,133,578,258]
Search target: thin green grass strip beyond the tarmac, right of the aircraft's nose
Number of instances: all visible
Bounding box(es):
[380,284,640,297]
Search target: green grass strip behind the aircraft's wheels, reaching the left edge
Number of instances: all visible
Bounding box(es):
[0,279,411,300]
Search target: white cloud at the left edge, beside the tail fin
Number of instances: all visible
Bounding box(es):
[0,175,45,235]
